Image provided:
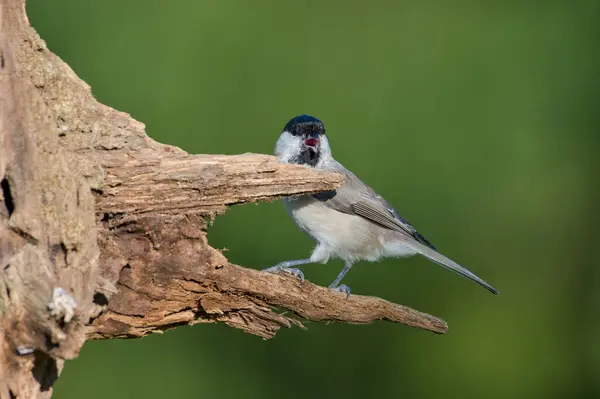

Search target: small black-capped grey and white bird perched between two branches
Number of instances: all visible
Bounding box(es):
[263,114,499,297]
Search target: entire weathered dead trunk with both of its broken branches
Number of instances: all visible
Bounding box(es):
[0,0,447,398]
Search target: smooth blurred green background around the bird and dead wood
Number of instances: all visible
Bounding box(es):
[28,0,600,399]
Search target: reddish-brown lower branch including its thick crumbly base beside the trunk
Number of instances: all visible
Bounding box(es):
[90,209,446,338]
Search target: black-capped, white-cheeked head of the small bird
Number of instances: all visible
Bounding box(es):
[275,115,331,167]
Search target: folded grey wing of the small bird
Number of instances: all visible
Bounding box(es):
[313,165,435,250]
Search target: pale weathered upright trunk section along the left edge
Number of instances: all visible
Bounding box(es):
[0,1,100,398]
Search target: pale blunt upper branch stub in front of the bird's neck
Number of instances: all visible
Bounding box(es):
[96,150,344,215]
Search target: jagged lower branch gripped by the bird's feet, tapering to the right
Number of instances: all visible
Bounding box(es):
[88,264,448,339]
